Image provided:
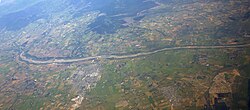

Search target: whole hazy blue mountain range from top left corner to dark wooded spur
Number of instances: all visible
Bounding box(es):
[0,0,156,31]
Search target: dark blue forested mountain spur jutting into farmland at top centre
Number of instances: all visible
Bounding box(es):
[84,0,156,34]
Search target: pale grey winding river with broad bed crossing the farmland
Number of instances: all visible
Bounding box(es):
[20,43,250,64]
